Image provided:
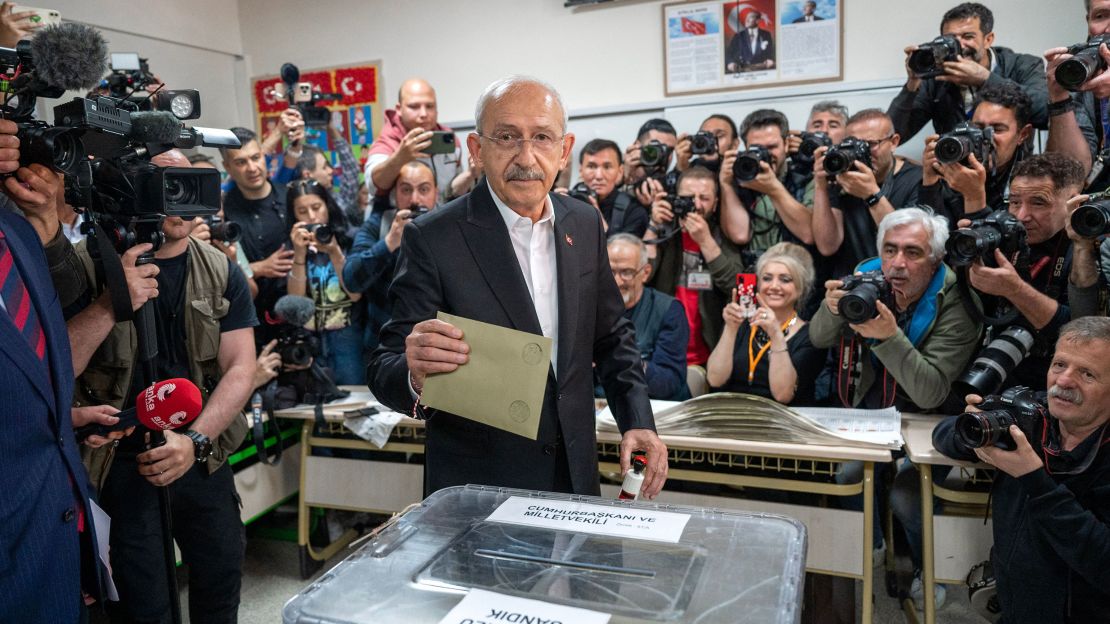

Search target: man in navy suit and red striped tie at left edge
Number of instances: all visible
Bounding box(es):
[0,120,101,622]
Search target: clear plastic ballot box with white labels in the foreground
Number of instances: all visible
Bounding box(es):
[282,485,806,624]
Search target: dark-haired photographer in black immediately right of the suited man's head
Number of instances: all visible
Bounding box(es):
[556,139,648,236]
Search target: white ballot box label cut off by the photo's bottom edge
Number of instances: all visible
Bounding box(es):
[440,590,609,624]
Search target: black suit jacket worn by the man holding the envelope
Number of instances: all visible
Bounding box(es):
[367,180,655,494]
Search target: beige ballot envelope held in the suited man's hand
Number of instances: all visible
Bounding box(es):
[421,312,552,440]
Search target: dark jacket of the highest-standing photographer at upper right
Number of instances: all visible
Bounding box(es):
[887,46,1048,142]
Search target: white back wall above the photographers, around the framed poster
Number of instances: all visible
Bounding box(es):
[239,0,1086,125]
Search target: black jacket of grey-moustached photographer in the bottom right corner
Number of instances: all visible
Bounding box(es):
[932,416,1110,624]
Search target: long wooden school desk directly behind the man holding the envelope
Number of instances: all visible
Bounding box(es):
[278,388,891,624]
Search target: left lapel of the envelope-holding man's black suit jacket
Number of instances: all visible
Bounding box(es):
[458,179,543,334]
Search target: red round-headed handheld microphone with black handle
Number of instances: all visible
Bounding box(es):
[74,378,202,443]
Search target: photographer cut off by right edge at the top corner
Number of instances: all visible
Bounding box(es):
[1045,0,1110,186]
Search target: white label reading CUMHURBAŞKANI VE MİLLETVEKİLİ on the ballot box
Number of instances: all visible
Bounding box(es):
[486,496,690,544]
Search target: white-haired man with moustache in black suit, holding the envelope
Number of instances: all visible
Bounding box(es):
[367,77,667,497]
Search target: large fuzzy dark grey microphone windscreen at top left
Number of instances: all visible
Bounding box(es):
[31,22,108,91]
